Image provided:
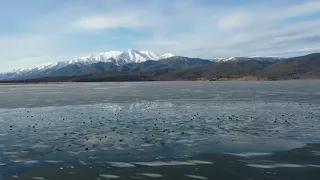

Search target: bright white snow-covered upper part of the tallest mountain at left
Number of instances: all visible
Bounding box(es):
[0,49,174,80]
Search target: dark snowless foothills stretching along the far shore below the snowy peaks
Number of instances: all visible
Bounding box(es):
[2,53,320,83]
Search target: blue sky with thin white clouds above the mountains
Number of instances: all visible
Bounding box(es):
[0,0,320,72]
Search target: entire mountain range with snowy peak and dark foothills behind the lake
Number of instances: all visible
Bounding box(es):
[0,49,320,82]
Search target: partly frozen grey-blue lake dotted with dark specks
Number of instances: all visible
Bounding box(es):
[0,81,320,180]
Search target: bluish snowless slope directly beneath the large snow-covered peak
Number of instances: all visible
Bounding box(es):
[0,57,212,80]
